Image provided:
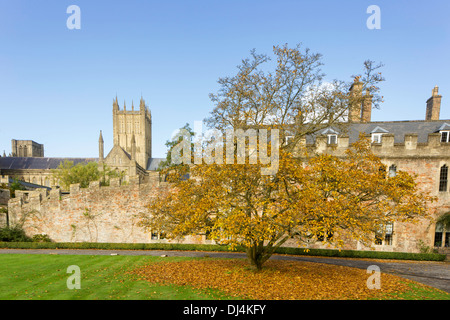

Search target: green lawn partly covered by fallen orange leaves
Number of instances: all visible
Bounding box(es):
[0,254,449,300]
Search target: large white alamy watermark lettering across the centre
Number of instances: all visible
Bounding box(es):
[171,121,280,175]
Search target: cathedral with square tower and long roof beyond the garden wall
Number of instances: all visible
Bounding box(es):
[0,97,163,187]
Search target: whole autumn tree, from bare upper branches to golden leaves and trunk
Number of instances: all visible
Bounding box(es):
[137,46,431,270]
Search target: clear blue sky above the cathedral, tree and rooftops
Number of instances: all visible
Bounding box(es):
[0,0,450,157]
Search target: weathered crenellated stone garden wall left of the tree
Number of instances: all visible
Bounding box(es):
[9,180,173,243]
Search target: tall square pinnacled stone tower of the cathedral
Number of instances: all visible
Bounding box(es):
[113,96,152,169]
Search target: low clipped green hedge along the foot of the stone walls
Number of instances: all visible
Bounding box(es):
[0,242,446,261]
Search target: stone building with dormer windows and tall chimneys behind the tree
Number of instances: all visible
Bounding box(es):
[284,82,450,252]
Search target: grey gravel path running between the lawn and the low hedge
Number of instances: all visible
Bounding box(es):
[0,249,450,293]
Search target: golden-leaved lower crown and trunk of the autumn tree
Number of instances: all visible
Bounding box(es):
[142,136,432,270]
